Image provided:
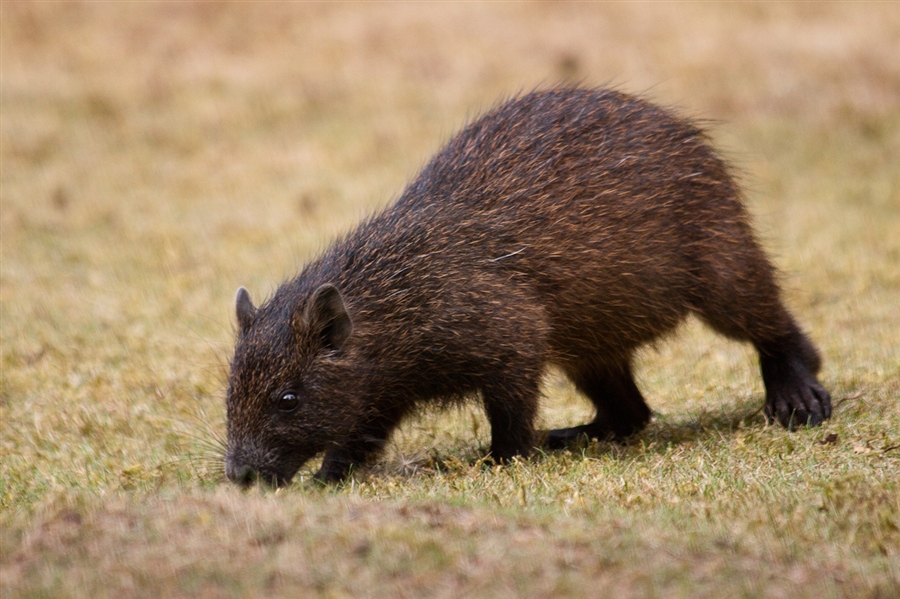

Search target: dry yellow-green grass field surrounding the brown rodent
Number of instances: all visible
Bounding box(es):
[0,2,900,599]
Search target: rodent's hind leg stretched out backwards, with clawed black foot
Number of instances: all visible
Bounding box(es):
[697,243,831,430]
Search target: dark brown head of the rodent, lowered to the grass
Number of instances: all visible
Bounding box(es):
[225,285,358,486]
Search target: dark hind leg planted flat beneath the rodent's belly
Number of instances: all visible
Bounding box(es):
[544,362,650,449]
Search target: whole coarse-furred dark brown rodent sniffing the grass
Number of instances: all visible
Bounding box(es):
[226,88,831,484]
